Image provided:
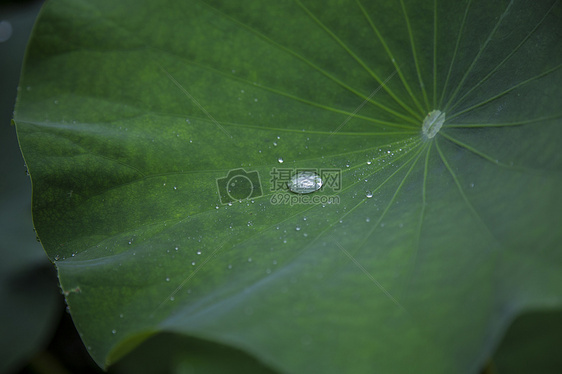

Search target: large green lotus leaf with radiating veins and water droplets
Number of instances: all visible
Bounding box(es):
[15,0,562,373]
